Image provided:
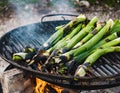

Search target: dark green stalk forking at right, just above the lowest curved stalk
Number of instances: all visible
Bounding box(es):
[65,33,117,72]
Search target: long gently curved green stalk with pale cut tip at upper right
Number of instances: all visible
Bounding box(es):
[60,19,113,61]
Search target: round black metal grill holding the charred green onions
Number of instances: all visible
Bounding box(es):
[0,14,120,90]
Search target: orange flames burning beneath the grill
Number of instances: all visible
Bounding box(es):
[35,78,63,93]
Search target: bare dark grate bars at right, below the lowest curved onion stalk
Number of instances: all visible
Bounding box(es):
[93,53,120,77]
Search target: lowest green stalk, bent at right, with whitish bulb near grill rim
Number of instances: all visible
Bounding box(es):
[75,46,120,77]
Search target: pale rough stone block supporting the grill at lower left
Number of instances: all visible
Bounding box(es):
[1,68,34,93]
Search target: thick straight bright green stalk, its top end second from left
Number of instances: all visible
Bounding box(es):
[61,16,98,53]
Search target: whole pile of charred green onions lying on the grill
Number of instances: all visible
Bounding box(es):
[13,15,120,77]
